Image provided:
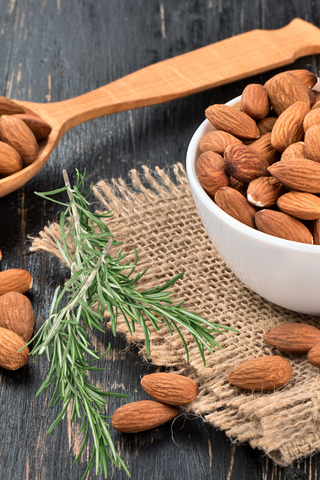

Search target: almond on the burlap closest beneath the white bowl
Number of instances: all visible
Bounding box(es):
[263,323,320,354]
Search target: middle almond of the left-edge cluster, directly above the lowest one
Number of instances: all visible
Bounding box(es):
[0,292,34,343]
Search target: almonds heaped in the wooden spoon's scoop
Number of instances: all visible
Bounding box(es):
[0,97,52,178]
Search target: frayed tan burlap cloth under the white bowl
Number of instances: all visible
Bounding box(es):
[31,164,320,465]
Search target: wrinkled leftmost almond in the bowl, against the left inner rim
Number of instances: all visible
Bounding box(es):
[196,152,229,196]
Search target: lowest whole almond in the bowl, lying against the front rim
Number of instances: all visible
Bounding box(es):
[255,210,313,244]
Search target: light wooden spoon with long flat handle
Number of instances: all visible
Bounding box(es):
[0,18,320,197]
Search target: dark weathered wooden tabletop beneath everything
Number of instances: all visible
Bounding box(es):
[0,0,320,480]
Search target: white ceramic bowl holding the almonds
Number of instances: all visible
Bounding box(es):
[187,97,320,315]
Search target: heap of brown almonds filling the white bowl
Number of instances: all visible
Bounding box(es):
[195,70,320,245]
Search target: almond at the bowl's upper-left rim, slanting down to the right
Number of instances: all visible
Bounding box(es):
[205,104,260,140]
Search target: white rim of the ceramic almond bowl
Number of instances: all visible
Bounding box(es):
[186,95,320,251]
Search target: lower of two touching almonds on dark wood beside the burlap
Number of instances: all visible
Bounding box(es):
[111,400,179,433]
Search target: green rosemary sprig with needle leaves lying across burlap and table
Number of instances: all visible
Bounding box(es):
[29,171,234,477]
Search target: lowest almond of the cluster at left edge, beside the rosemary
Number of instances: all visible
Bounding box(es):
[0,327,30,370]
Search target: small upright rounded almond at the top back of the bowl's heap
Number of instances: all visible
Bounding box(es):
[241,83,270,121]
